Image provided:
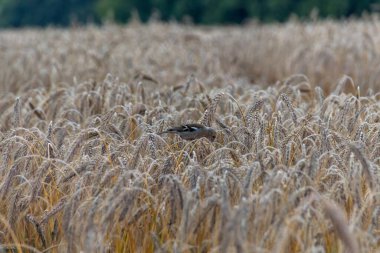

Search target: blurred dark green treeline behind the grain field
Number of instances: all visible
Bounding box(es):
[0,0,380,27]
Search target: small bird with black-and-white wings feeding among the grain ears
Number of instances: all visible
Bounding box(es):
[159,124,216,141]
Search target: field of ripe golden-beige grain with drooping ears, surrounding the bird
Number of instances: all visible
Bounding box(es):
[0,17,380,253]
